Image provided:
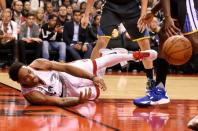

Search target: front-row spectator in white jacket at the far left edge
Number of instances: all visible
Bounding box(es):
[0,9,17,61]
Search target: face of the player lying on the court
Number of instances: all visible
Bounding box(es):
[18,66,39,87]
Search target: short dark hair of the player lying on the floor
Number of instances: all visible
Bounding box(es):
[9,62,24,81]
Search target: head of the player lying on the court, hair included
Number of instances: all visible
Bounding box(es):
[9,62,39,86]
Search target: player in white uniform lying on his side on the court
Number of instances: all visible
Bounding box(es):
[9,50,157,106]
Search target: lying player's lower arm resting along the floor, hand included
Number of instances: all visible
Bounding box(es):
[25,88,92,106]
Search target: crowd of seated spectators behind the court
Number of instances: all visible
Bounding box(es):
[0,0,196,72]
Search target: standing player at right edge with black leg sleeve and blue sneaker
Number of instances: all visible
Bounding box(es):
[134,0,198,106]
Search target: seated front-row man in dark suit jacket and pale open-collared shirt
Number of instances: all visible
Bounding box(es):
[63,10,92,60]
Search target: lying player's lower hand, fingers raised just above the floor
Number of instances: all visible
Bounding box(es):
[79,88,92,103]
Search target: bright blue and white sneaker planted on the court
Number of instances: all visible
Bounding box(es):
[133,83,170,107]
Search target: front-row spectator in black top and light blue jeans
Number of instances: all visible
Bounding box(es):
[40,14,66,62]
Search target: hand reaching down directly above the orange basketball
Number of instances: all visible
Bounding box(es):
[164,17,180,37]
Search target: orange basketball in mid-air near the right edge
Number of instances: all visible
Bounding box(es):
[163,35,192,65]
